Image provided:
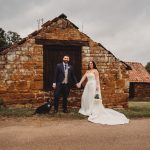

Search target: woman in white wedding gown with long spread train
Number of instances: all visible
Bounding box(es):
[78,61,129,125]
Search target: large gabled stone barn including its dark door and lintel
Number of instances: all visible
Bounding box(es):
[0,14,130,107]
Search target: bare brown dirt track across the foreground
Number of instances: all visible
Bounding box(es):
[0,117,150,150]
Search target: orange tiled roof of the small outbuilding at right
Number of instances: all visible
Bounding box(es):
[126,62,150,83]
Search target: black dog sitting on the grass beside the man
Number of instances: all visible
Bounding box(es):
[34,99,52,114]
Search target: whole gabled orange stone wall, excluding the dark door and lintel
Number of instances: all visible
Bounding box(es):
[0,18,128,107]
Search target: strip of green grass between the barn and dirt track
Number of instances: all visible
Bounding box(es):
[0,101,150,120]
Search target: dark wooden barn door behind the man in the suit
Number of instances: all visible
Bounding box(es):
[43,45,82,91]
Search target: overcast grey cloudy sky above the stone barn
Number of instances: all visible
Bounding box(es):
[0,0,150,65]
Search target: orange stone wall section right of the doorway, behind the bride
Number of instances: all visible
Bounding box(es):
[82,41,129,107]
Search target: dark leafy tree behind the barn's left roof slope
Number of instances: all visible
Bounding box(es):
[0,28,21,51]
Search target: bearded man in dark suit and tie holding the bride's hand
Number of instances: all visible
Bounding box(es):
[53,55,78,113]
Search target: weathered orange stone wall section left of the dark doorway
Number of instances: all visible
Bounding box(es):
[0,39,43,104]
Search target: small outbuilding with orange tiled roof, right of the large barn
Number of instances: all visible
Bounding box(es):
[126,62,150,100]
